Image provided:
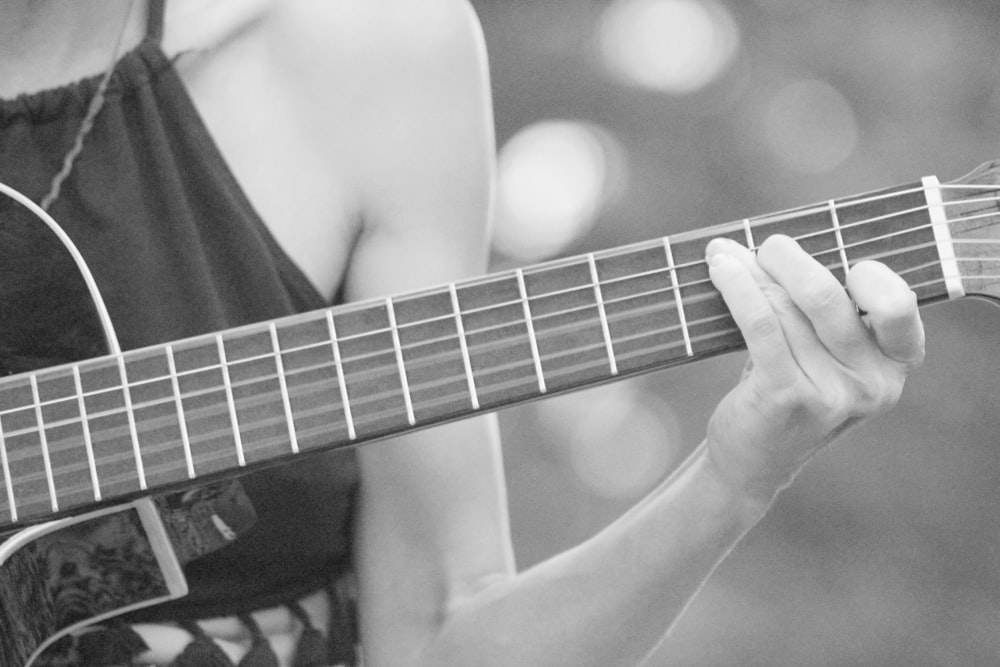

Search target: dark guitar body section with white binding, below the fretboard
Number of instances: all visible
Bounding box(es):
[0,499,187,667]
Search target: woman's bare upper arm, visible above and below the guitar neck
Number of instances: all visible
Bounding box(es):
[284,0,513,664]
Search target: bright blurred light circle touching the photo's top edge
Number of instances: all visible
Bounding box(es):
[599,0,740,95]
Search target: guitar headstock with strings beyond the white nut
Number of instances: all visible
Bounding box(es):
[941,160,1000,300]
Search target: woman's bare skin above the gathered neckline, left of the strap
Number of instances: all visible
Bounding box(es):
[0,0,146,99]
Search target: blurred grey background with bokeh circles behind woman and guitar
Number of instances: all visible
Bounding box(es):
[474,0,1000,666]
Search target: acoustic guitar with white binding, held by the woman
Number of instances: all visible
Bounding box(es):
[0,162,1000,667]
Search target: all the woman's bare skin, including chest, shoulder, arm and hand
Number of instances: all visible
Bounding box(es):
[0,0,924,667]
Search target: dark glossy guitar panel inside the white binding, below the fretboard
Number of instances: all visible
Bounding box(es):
[0,508,168,665]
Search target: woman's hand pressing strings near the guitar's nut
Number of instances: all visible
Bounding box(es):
[707,236,924,506]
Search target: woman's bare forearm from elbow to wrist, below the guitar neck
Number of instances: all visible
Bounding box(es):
[419,447,765,666]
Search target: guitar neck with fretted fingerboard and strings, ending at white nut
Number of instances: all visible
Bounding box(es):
[0,174,996,528]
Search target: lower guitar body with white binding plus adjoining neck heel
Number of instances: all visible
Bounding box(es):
[0,479,256,667]
